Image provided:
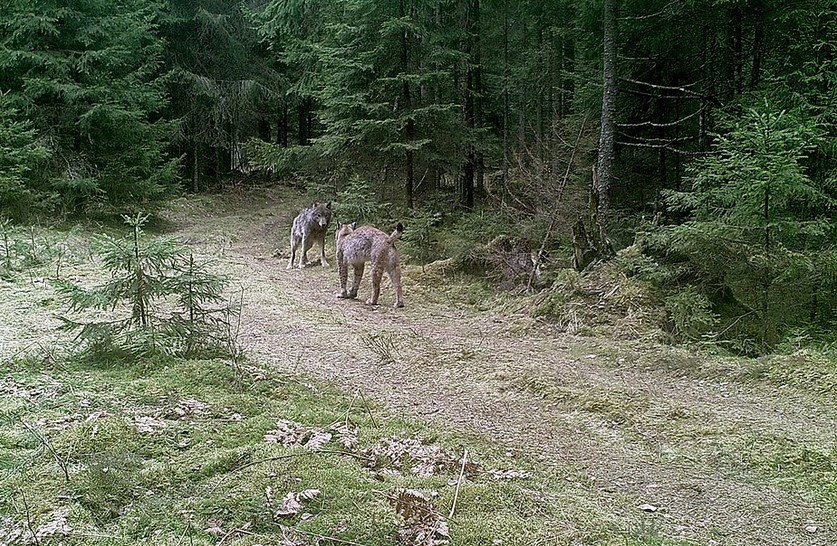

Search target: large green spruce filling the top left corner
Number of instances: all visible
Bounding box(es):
[0,0,176,212]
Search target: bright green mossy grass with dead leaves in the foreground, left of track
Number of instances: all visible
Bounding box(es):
[0,348,674,546]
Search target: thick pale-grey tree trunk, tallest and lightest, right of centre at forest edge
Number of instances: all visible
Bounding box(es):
[596,0,616,237]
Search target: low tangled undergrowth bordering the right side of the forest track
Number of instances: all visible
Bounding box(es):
[310,175,837,356]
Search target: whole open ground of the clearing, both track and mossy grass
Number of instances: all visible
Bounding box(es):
[0,185,837,546]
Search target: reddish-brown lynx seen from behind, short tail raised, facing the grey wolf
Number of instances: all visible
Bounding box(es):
[335,224,404,307]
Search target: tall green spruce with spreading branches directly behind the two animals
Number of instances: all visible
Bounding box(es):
[248,0,470,204]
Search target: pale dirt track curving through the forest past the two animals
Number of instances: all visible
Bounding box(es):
[170,188,837,546]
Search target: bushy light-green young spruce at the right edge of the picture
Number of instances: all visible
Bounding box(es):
[666,102,837,347]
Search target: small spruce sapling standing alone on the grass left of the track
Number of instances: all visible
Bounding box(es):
[55,214,237,354]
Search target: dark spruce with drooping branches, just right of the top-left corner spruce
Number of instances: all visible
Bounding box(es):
[160,0,284,188]
